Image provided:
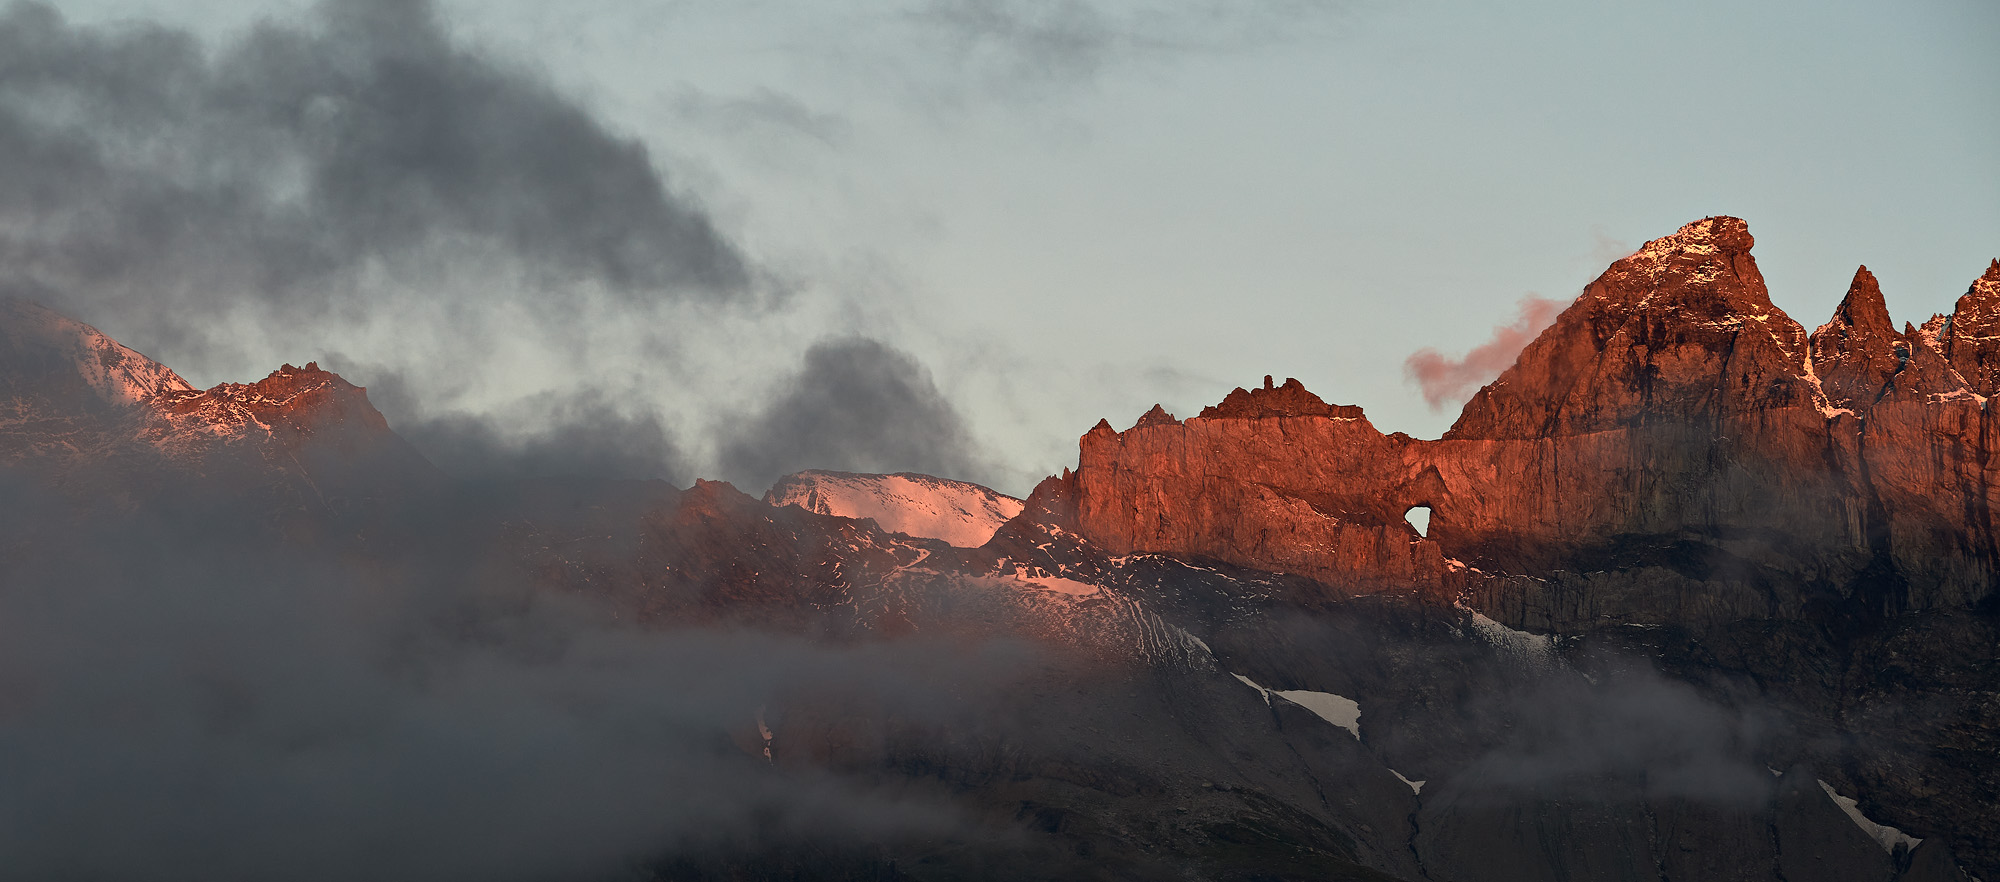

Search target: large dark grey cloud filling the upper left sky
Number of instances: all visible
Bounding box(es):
[0,0,752,324]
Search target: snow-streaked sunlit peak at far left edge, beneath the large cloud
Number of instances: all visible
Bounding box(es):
[0,298,194,406]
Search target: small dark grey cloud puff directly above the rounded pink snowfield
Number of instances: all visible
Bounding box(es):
[722,338,984,492]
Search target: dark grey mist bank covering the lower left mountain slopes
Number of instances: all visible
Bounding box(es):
[0,470,1032,882]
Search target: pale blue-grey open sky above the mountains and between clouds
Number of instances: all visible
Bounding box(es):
[27,0,2000,494]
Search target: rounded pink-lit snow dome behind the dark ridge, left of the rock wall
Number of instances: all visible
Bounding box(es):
[764,470,1022,548]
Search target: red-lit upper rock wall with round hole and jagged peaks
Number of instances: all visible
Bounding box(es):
[1068,218,2000,626]
